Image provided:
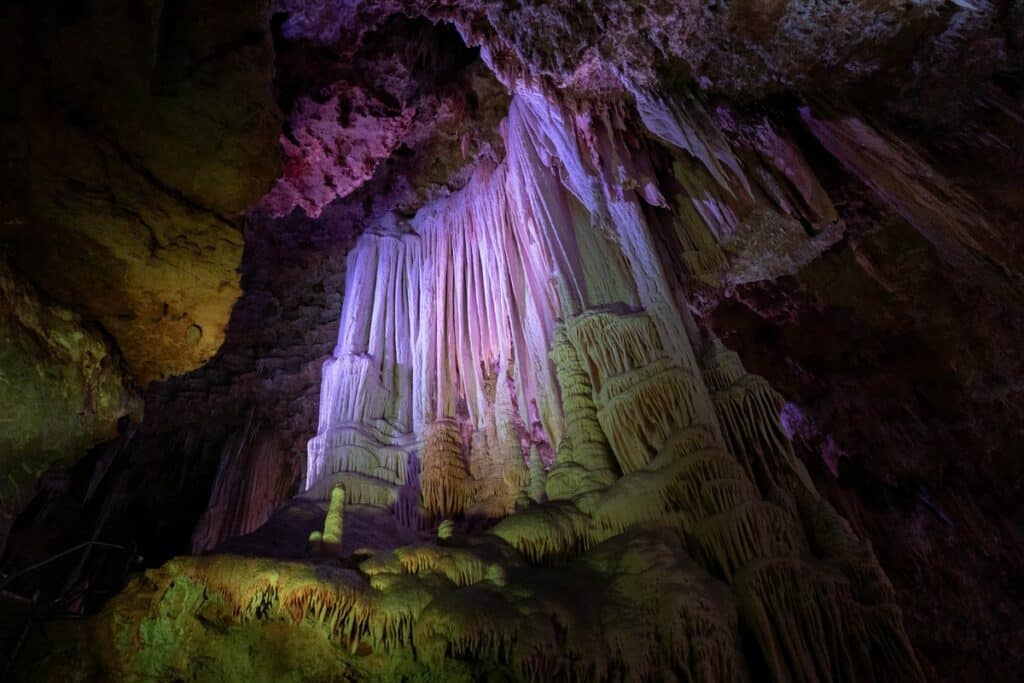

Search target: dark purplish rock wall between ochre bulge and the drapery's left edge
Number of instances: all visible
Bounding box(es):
[0,206,353,590]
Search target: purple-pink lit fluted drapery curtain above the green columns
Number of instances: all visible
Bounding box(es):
[306,85,737,501]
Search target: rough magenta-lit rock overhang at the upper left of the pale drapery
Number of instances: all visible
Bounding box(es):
[262,16,508,217]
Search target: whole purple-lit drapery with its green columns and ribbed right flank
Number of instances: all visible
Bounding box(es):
[306,83,921,681]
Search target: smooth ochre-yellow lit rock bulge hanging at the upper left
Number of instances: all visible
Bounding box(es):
[2,0,280,385]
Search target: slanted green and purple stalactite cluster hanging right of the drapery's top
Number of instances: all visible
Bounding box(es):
[631,87,845,287]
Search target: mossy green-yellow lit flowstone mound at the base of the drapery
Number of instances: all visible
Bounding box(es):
[34,335,921,681]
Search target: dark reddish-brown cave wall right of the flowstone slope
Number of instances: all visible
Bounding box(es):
[708,107,1024,680]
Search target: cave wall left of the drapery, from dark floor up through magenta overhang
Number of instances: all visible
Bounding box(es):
[0,7,507,592]
